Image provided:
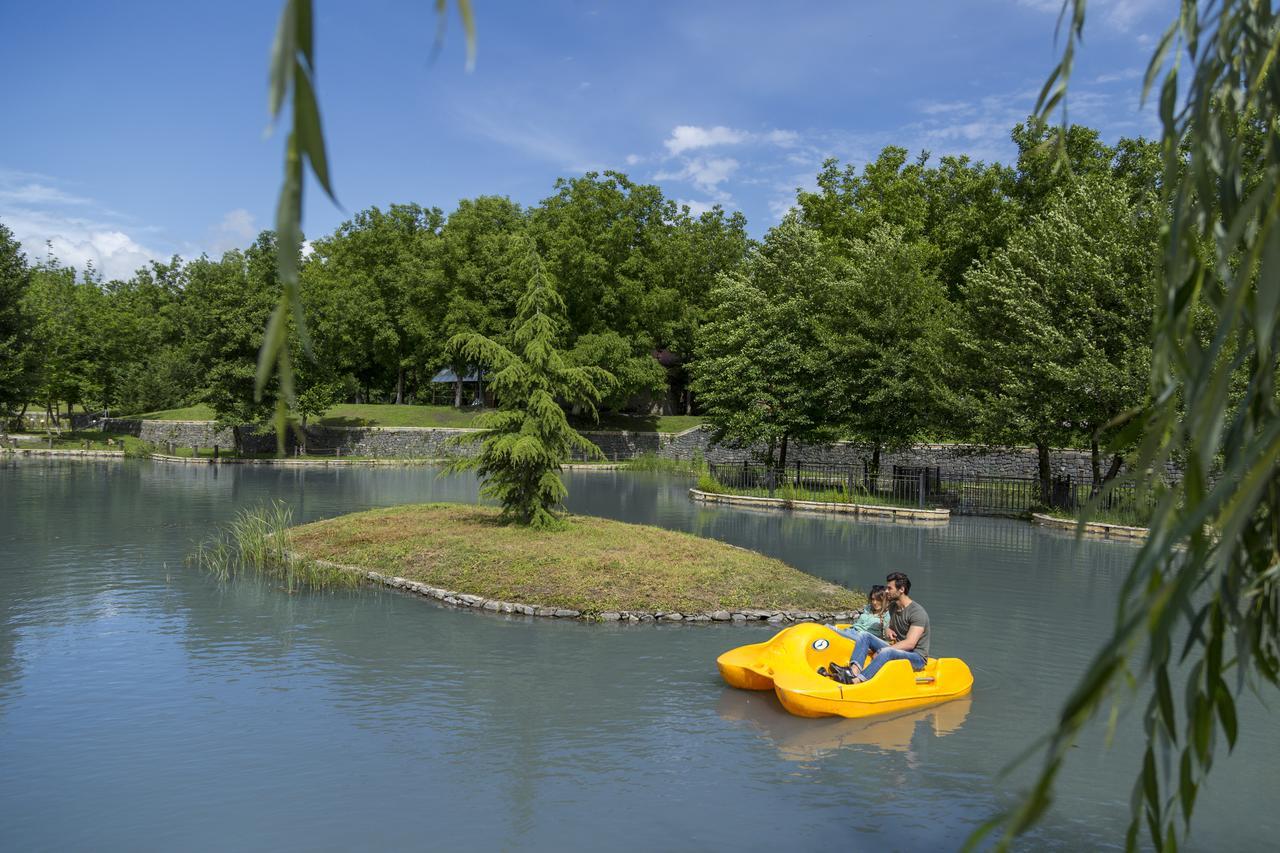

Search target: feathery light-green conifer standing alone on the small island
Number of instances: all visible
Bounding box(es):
[449,247,613,528]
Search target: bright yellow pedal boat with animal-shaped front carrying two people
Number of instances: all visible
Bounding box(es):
[716,622,973,717]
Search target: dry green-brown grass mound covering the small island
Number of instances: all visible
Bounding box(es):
[289,503,865,613]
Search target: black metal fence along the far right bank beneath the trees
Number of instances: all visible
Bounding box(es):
[708,461,1152,525]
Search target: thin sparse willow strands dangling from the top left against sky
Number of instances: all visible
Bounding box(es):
[256,0,475,453]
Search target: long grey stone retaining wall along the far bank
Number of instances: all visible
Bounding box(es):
[100,418,1181,480]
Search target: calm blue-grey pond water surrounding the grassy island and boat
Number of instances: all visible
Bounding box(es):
[0,461,1280,852]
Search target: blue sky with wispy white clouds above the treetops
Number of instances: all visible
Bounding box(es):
[0,0,1175,277]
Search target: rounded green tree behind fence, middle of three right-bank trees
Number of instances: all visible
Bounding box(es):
[820,225,955,481]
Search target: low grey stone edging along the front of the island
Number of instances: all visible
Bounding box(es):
[304,560,856,625]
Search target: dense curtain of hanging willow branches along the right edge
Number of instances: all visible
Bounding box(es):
[970,0,1280,850]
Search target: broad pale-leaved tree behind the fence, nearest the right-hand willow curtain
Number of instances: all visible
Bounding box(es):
[963,173,1156,503]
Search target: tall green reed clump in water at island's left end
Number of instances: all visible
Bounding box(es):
[187,501,361,592]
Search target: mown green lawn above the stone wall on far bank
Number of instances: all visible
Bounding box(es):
[138,403,703,433]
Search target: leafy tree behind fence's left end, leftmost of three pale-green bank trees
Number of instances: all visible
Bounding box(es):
[692,216,835,467]
